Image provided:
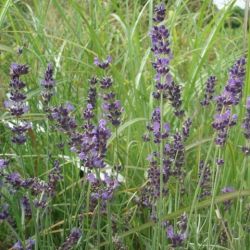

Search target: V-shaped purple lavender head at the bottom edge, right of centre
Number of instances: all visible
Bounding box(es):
[164,213,187,247]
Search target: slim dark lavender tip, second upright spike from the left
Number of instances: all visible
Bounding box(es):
[41,63,55,105]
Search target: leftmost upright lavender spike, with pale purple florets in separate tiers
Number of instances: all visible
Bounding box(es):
[4,63,31,144]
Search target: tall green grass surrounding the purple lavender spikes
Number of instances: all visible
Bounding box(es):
[0,0,250,250]
